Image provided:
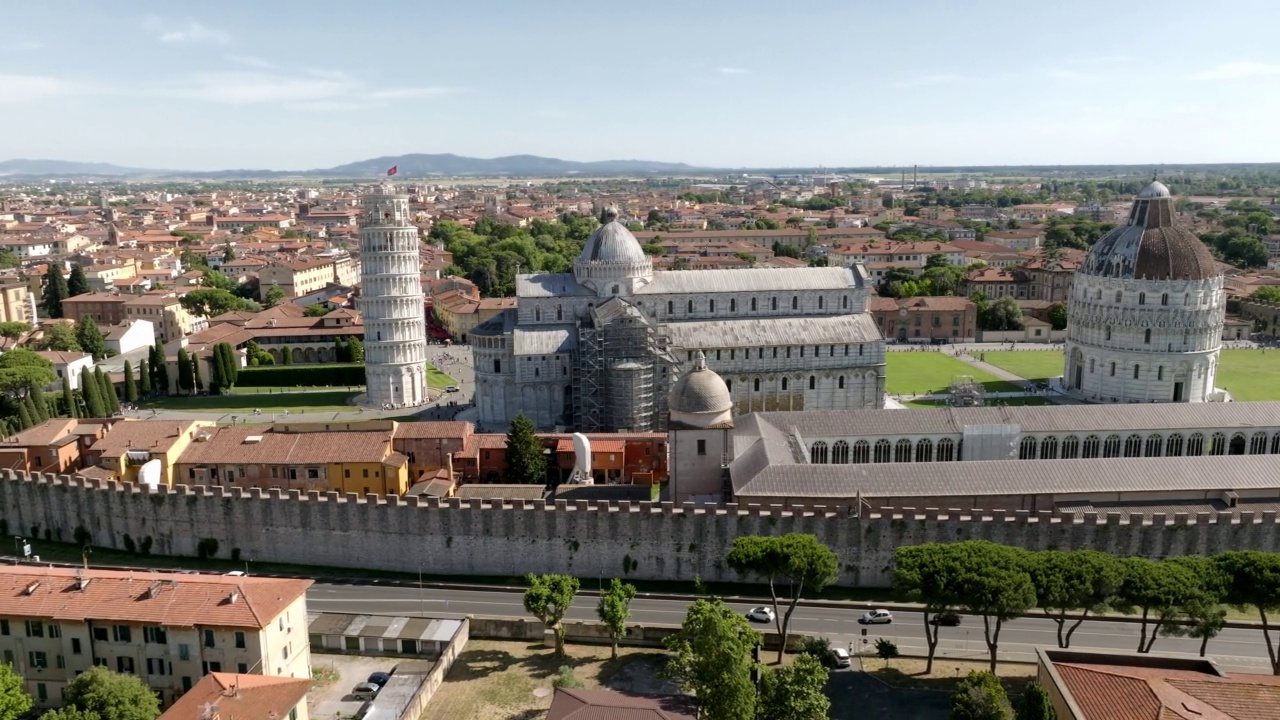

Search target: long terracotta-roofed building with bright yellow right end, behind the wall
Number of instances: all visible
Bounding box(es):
[174,420,410,495]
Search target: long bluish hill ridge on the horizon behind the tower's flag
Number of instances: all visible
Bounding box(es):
[317,152,698,177]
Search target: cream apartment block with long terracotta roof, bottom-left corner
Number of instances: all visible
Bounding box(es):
[0,566,311,707]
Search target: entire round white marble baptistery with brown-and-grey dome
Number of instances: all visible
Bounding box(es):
[1064,182,1226,402]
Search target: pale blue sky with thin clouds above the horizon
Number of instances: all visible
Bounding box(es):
[0,0,1280,169]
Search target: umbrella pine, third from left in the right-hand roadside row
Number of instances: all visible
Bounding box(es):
[1028,550,1124,648]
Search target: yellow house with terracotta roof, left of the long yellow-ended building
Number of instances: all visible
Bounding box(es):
[82,420,214,487]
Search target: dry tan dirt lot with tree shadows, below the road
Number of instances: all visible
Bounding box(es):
[421,641,675,720]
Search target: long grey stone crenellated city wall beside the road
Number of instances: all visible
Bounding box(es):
[0,470,1280,587]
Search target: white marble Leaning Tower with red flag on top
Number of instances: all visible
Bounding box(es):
[360,186,426,407]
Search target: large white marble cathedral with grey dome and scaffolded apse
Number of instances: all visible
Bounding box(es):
[470,211,884,432]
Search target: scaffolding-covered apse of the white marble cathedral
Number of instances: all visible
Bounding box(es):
[572,299,675,433]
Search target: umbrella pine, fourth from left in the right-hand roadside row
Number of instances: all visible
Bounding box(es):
[1112,557,1198,652]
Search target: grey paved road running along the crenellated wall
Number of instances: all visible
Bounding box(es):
[307,583,1267,673]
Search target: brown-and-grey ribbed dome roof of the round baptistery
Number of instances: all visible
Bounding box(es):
[1080,182,1221,281]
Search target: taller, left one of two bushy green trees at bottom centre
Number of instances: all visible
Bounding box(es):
[663,598,762,720]
